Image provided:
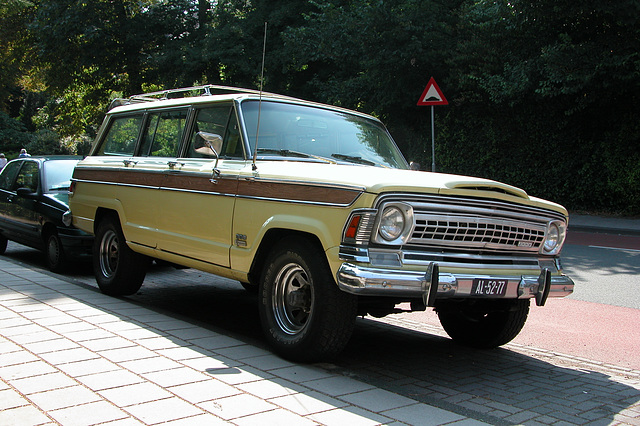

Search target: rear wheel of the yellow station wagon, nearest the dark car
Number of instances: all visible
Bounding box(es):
[93,216,151,296]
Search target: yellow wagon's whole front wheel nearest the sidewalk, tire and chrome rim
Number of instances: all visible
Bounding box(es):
[259,238,357,362]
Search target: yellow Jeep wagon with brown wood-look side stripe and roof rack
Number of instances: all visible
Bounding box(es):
[66,86,574,361]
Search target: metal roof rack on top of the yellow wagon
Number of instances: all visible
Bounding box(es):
[109,84,289,110]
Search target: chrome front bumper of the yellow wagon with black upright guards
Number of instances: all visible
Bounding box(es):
[337,262,574,306]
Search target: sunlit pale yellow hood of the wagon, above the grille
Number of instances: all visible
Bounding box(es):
[248,161,567,215]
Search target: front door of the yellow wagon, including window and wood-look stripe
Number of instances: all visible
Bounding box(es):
[157,104,245,267]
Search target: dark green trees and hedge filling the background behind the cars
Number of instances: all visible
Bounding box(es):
[0,0,640,215]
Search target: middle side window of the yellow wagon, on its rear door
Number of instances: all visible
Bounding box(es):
[140,109,187,157]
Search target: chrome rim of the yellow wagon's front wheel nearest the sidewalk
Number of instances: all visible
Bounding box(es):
[272,263,313,335]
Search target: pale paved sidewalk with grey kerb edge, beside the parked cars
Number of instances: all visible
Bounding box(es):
[0,260,481,426]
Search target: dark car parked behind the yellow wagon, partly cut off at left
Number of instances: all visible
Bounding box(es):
[0,156,93,272]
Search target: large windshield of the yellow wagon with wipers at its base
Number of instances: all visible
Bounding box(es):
[242,101,408,169]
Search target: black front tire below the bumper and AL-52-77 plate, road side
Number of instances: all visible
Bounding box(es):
[436,299,529,349]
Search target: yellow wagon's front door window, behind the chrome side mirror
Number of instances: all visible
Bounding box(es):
[187,105,244,158]
